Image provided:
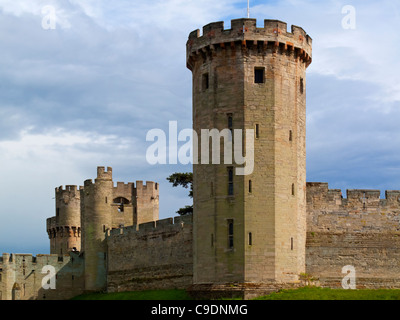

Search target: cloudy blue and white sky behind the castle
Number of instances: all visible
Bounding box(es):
[0,0,400,254]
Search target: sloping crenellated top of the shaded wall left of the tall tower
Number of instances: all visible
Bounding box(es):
[107,215,193,237]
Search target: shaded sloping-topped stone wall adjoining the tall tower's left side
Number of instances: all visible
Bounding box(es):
[107,215,193,292]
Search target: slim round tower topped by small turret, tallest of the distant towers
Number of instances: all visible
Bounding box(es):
[81,167,113,291]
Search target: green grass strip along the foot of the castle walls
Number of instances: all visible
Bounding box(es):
[72,287,400,300]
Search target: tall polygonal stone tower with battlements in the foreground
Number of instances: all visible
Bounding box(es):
[187,19,312,296]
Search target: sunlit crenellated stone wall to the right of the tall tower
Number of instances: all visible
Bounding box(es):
[306,183,400,288]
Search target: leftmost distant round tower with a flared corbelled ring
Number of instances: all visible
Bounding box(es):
[47,186,81,255]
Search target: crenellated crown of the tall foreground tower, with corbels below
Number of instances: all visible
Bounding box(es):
[186,19,312,69]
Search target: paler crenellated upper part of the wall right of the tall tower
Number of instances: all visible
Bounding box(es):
[307,182,400,234]
